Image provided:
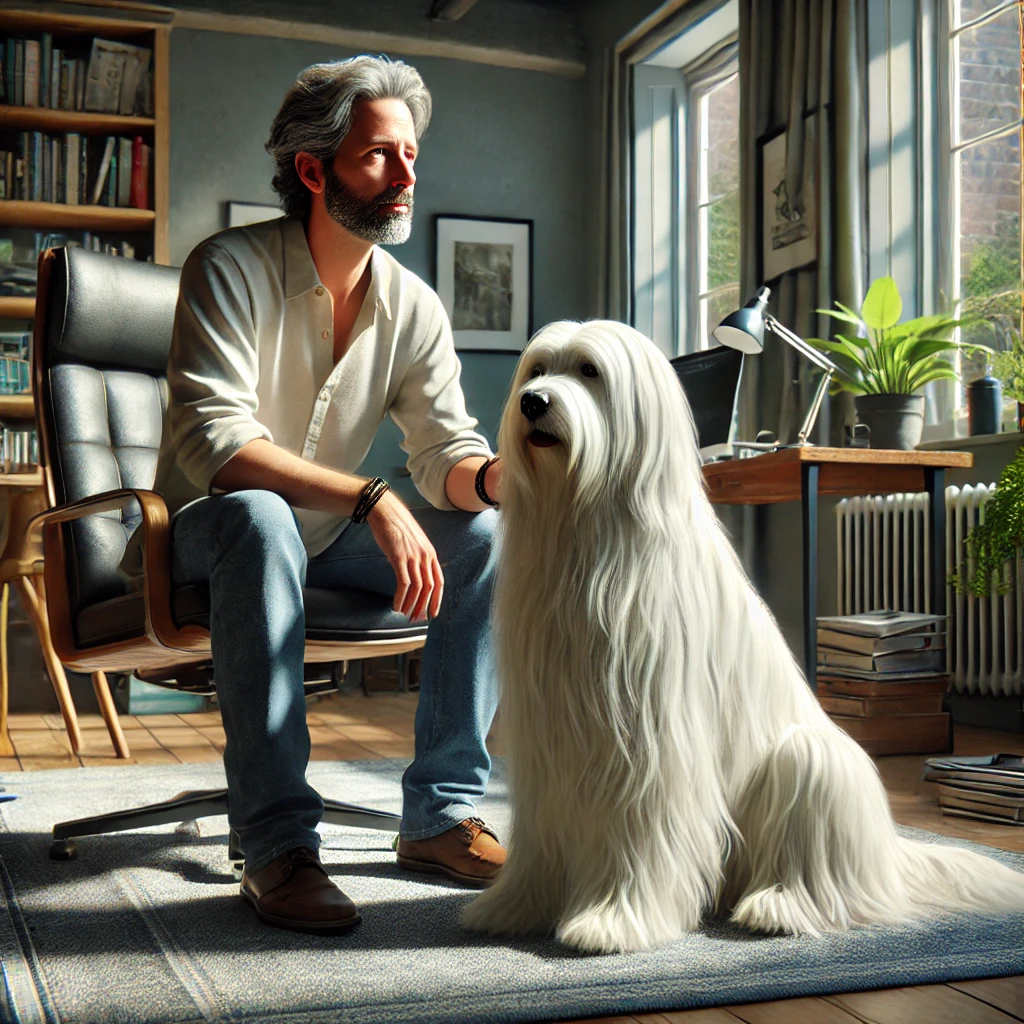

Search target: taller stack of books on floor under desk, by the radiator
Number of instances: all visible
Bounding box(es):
[817,610,952,754]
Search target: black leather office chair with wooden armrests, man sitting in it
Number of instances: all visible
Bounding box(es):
[30,248,426,861]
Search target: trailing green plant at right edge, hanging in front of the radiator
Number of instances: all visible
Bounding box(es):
[949,447,1024,597]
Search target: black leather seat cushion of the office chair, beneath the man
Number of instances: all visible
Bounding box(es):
[75,584,427,647]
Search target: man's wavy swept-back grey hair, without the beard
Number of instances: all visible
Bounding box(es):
[266,54,430,217]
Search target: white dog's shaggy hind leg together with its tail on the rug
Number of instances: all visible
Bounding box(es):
[721,725,1024,935]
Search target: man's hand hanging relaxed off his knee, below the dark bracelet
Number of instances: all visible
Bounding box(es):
[367,490,444,623]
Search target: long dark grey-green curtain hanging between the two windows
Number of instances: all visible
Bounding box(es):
[738,0,867,444]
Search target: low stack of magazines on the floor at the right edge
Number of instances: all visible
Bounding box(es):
[924,754,1024,825]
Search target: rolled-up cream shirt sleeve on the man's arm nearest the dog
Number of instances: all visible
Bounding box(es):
[389,297,492,511]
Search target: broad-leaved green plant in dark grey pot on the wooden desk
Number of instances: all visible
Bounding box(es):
[807,278,985,450]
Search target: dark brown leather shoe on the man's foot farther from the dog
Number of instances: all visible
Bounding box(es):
[240,846,359,932]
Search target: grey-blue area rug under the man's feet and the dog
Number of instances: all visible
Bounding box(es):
[0,761,1024,1024]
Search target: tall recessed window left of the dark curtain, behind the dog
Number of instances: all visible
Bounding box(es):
[633,0,739,357]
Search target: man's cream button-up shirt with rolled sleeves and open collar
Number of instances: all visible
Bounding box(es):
[122,218,492,573]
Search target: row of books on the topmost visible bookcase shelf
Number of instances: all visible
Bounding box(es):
[0,32,153,117]
